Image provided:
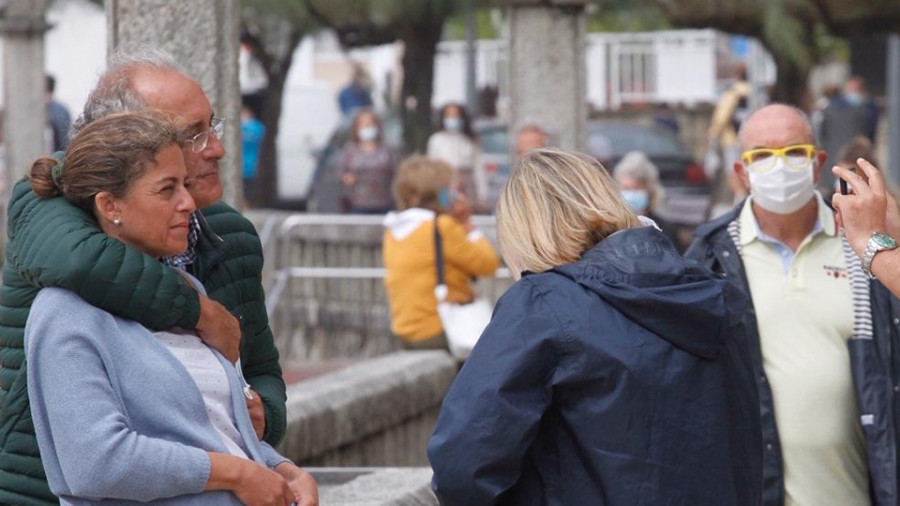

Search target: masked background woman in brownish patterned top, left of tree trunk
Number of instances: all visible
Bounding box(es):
[340,109,399,214]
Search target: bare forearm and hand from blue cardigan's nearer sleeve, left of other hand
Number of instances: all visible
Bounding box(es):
[206,452,295,506]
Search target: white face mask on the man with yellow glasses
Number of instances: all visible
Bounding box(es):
[749,157,815,214]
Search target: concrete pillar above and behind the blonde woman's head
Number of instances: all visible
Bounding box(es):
[497,0,589,151]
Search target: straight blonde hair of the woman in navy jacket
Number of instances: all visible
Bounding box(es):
[497,149,640,277]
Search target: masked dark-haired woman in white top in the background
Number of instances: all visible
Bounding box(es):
[428,103,487,211]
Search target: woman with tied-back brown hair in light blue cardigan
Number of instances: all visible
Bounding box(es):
[25,112,318,506]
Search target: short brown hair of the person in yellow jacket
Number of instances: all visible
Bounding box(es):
[393,155,453,212]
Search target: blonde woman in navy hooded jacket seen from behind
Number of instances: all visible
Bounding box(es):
[428,149,762,506]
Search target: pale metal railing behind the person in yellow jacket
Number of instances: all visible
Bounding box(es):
[260,214,511,360]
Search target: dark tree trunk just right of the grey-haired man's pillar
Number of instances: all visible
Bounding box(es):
[252,34,300,207]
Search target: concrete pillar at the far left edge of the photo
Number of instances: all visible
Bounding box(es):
[0,0,49,186]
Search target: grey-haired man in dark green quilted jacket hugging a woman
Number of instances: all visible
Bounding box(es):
[0,47,298,504]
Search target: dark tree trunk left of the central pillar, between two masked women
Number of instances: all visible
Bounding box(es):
[400,18,444,153]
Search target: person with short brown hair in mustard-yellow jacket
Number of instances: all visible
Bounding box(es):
[384,156,500,349]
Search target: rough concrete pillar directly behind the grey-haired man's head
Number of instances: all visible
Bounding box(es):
[106,0,243,205]
